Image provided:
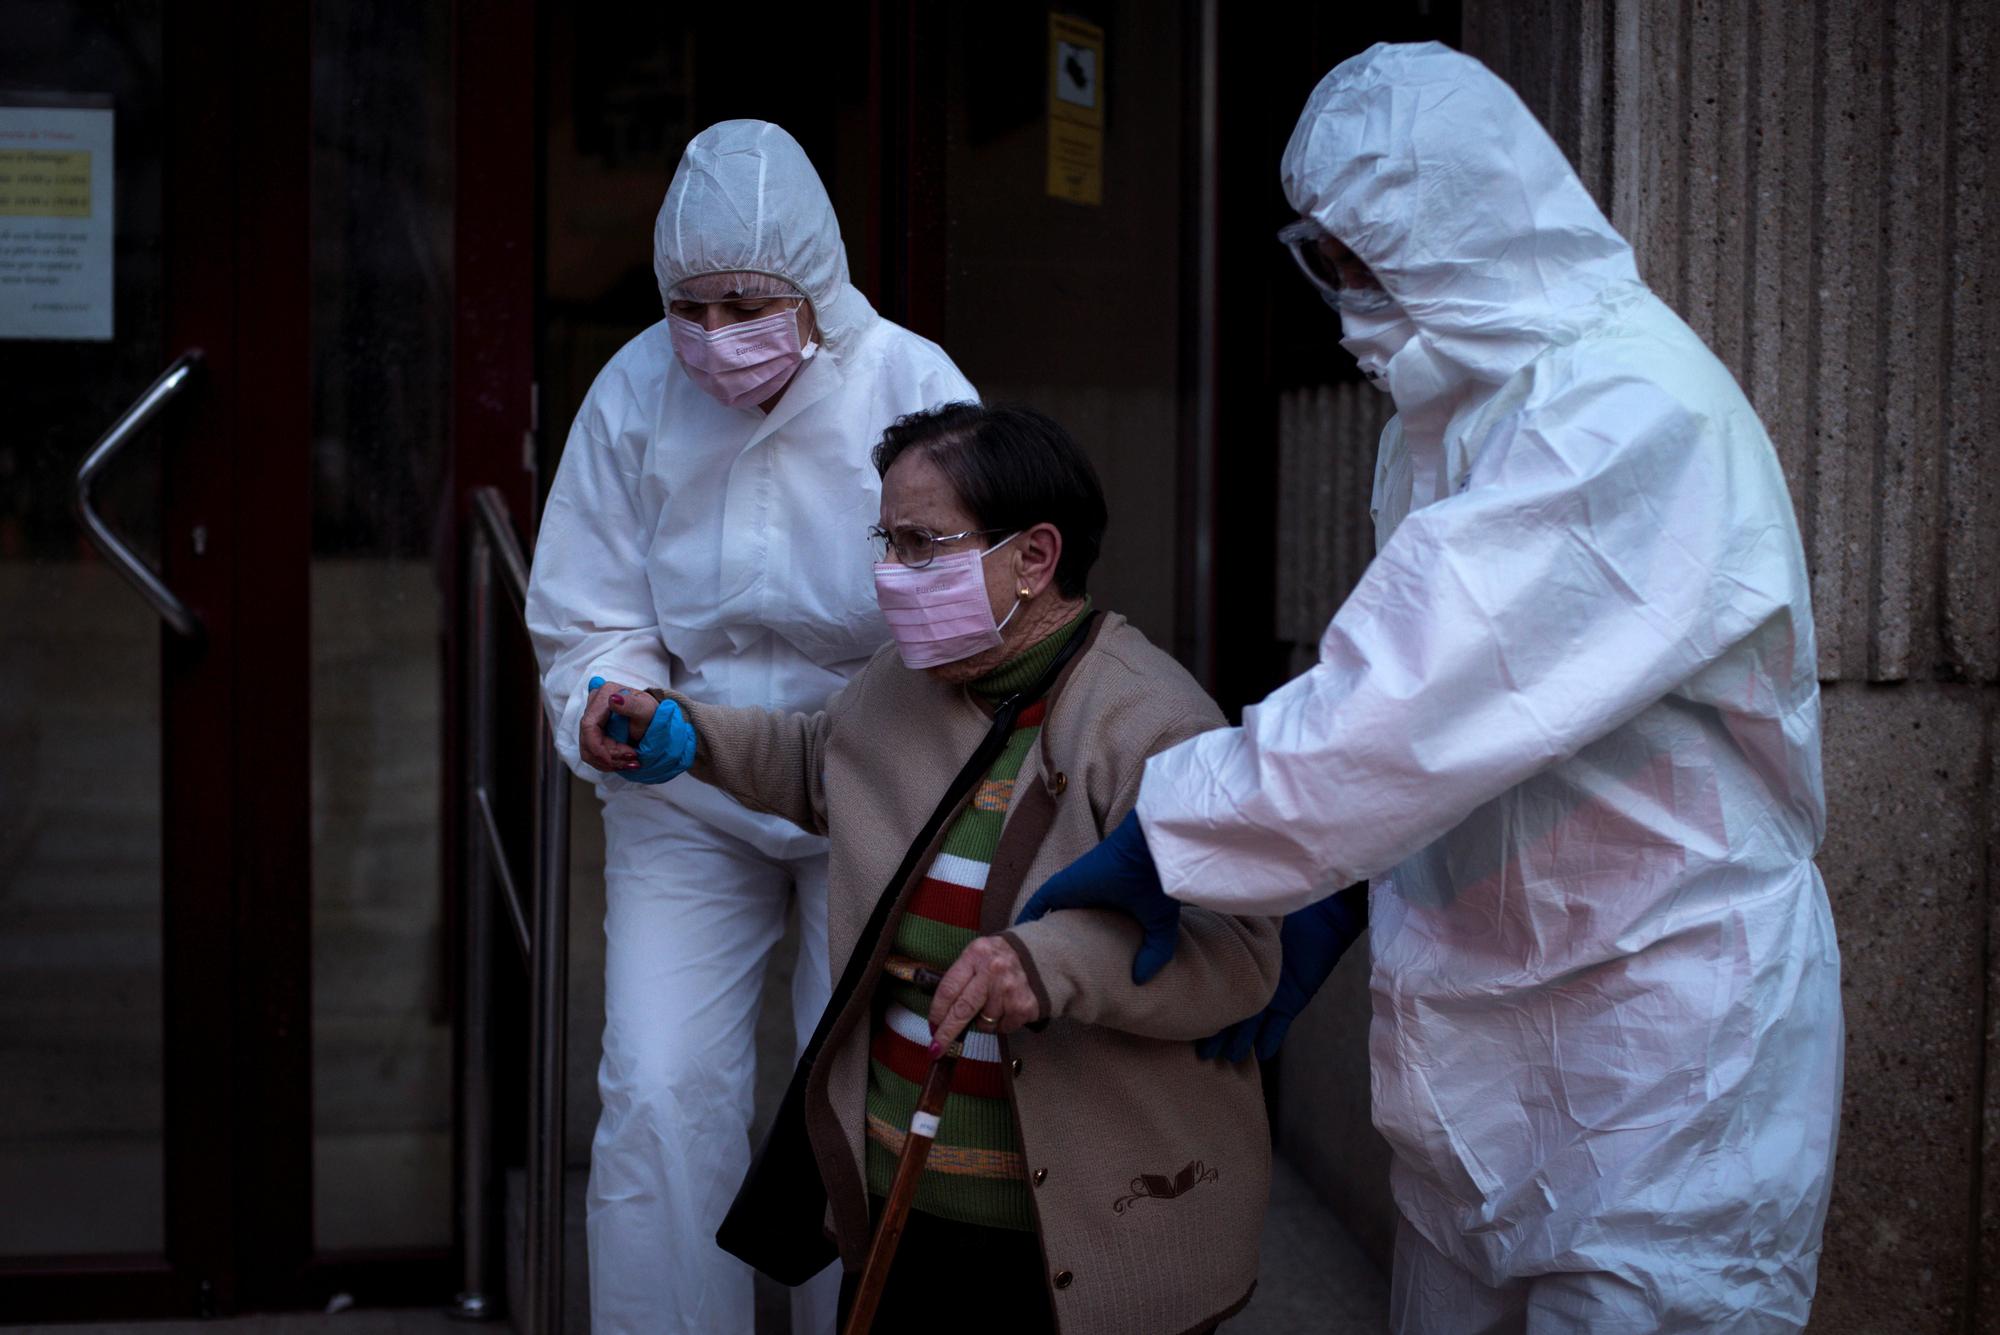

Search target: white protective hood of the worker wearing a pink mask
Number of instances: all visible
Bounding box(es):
[652,120,876,350]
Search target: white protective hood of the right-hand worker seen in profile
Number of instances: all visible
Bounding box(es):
[1280,42,1640,414]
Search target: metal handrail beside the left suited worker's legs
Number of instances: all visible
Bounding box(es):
[452,488,570,1335]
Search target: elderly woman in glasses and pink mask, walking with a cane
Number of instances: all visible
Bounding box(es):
[606,404,1278,1335]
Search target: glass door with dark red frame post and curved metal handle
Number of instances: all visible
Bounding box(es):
[0,0,310,1321]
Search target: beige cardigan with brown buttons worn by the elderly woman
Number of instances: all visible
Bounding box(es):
[672,614,1278,1335]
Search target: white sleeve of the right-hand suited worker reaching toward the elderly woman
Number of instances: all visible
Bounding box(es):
[1138,378,1800,913]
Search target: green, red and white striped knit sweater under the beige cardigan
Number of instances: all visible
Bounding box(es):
[868,602,1090,1229]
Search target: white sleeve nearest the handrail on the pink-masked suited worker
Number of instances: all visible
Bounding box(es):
[528,372,672,783]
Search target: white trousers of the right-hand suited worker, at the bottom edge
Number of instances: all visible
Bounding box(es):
[1388,1219,1812,1335]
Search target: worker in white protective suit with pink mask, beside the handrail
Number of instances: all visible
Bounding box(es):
[528,120,974,1335]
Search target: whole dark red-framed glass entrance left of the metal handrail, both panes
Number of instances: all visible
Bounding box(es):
[0,0,468,1321]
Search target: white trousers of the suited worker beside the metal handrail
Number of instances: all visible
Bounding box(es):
[588,791,840,1335]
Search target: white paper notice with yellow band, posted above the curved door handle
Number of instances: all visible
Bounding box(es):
[0,98,116,340]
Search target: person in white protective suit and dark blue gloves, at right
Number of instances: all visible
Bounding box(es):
[1026,44,1842,1333]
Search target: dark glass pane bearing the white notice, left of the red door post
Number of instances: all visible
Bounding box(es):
[0,4,172,1259]
